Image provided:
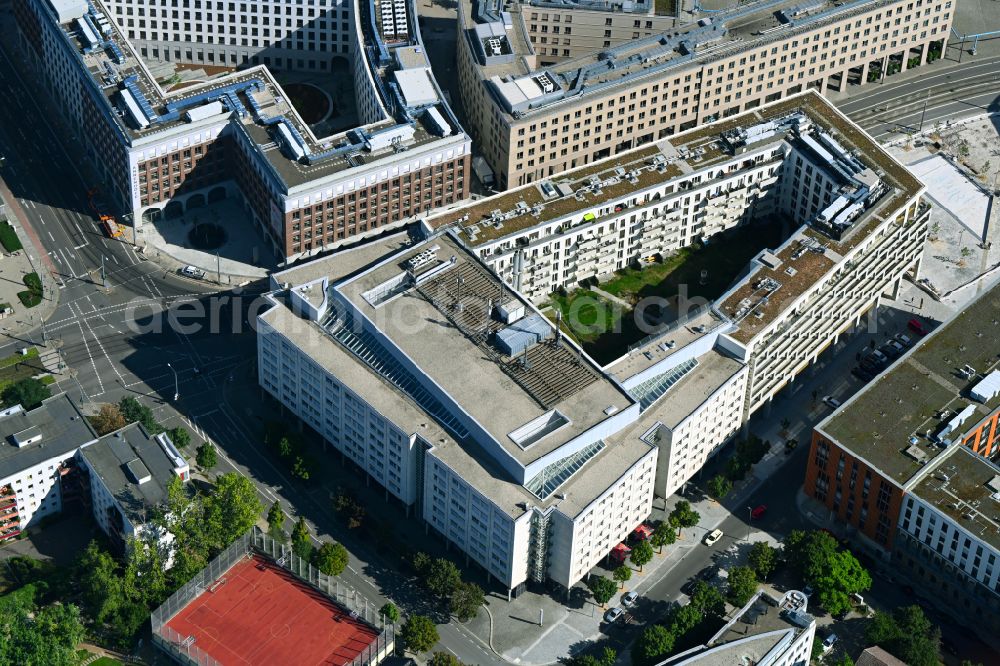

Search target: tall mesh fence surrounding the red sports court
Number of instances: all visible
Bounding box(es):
[150,527,396,666]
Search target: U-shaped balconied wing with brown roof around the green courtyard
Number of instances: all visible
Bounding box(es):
[426,92,930,420]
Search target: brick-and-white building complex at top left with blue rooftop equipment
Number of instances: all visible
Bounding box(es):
[15,0,470,261]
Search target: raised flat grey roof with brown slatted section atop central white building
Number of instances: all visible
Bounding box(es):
[336,234,632,464]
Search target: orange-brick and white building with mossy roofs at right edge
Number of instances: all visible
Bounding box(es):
[803,285,1000,642]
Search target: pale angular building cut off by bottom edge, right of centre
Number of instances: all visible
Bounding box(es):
[657,590,816,666]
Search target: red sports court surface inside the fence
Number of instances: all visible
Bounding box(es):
[167,557,377,666]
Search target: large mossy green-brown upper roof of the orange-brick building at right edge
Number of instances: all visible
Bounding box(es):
[817,284,1000,485]
